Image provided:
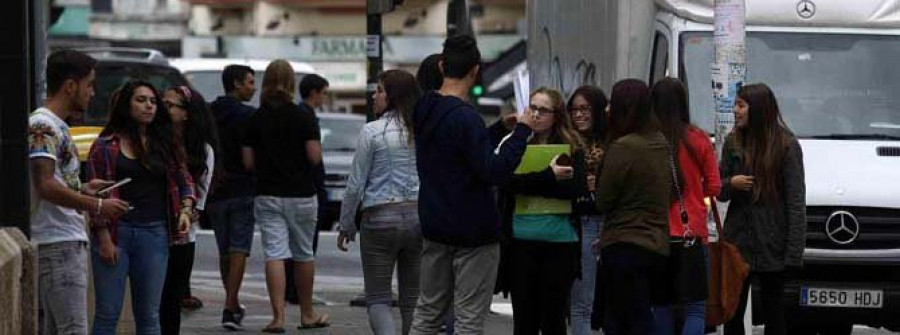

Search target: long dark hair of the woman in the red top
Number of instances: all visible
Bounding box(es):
[650,78,699,200]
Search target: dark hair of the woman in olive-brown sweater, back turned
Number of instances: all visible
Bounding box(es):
[609,79,659,141]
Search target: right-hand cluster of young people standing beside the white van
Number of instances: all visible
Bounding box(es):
[337,36,805,334]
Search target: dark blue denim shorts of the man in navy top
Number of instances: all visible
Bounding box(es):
[207,197,254,255]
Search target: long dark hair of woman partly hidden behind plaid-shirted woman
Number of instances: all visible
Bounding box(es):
[169,86,219,181]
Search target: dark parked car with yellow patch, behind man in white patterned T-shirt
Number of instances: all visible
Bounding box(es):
[71,48,188,162]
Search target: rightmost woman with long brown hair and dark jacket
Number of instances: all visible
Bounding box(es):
[719,84,806,335]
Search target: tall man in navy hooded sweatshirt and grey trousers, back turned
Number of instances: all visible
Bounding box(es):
[411,35,534,335]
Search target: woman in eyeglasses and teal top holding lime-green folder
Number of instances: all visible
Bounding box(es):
[498,88,583,335]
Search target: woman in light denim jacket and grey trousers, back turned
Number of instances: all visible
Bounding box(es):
[337,70,422,335]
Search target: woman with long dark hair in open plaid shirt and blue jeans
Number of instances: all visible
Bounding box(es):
[88,81,195,334]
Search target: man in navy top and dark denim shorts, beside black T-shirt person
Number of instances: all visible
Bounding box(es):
[210,65,256,330]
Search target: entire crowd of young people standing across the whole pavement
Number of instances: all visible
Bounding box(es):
[28,36,805,334]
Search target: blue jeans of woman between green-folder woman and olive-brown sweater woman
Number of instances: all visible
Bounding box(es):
[570,215,603,335]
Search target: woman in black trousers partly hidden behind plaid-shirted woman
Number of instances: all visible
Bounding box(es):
[159,86,219,334]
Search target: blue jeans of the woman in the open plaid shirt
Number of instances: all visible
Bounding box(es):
[91,221,169,335]
